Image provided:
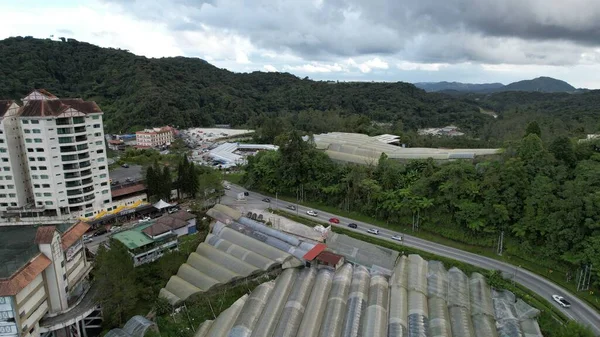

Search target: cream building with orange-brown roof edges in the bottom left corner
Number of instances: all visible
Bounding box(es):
[0,222,98,337]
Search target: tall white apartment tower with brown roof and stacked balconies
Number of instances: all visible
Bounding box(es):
[0,89,111,218]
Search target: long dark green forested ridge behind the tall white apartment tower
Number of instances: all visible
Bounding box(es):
[0,37,491,132]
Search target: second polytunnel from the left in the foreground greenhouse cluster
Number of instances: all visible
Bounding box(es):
[228,281,275,337]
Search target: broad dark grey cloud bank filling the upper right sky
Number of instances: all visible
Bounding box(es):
[105,0,600,65]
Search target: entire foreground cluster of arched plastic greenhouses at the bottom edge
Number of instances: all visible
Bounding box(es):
[195,255,542,337]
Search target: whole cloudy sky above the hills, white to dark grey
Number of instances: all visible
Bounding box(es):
[0,0,600,88]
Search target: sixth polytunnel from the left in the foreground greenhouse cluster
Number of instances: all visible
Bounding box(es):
[319,263,352,337]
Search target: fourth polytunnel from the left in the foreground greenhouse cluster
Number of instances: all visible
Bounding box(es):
[274,268,317,337]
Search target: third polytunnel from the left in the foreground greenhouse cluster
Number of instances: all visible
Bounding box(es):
[252,268,298,337]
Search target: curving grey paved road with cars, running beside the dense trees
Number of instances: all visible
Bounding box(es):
[226,185,600,336]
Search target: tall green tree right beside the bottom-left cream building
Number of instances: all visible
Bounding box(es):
[93,239,138,328]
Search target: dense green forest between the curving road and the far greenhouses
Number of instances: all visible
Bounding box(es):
[243,124,600,280]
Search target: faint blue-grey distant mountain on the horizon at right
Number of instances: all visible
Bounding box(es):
[415,76,585,94]
